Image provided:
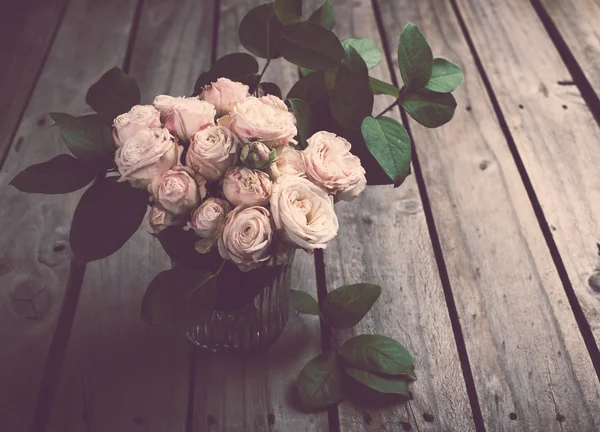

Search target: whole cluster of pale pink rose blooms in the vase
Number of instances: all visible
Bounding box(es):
[113,78,366,271]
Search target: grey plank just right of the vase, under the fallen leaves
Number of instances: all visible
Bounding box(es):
[314,0,475,432]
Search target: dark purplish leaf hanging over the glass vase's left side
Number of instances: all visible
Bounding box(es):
[142,266,218,331]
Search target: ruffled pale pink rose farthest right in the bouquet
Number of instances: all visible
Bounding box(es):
[302,131,367,201]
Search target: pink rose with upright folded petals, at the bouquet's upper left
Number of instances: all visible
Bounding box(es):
[154,95,217,141]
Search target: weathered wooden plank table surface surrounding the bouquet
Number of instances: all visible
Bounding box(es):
[0,0,600,432]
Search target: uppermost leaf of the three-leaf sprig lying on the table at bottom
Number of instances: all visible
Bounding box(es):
[340,334,414,377]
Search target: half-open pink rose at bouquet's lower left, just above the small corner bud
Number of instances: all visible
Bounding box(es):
[148,165,206,215]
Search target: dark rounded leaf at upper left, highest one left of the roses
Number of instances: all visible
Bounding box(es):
[85,68,141,123]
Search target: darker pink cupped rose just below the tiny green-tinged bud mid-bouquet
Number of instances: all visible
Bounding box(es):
[223,166,271,207]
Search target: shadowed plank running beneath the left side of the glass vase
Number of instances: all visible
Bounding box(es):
[48,0,218,432]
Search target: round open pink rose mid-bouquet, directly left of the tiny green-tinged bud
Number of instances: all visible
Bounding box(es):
[185,126,238,181]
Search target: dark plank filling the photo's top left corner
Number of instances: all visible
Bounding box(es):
[0,0,68,159]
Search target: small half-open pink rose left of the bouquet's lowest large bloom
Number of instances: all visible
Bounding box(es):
[186,198,231,253]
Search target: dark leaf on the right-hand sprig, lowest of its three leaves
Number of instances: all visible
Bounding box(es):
[401,89,456,128]
